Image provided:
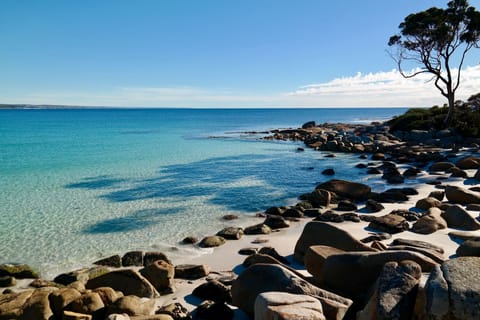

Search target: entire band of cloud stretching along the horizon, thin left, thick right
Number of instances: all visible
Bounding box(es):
[4,65,480,108]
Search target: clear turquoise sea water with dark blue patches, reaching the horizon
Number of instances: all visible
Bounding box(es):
[0,109,405,277]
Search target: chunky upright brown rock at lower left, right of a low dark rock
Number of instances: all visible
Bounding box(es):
[140,260,175,294]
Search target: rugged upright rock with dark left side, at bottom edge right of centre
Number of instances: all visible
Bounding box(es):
[357,261,422,320]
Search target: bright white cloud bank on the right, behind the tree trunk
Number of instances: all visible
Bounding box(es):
[286,66,480,107]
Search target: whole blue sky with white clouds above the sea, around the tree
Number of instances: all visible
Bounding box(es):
[0,0,480,108]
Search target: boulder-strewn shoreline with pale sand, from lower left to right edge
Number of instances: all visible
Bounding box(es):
[0,122,480,320]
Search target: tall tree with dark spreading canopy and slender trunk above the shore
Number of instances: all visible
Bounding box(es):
[388,0,480,126]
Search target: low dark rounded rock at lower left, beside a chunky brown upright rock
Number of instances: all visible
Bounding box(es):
[86,269,157,298]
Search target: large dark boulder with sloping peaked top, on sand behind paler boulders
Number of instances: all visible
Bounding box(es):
[294,221,374,263]
